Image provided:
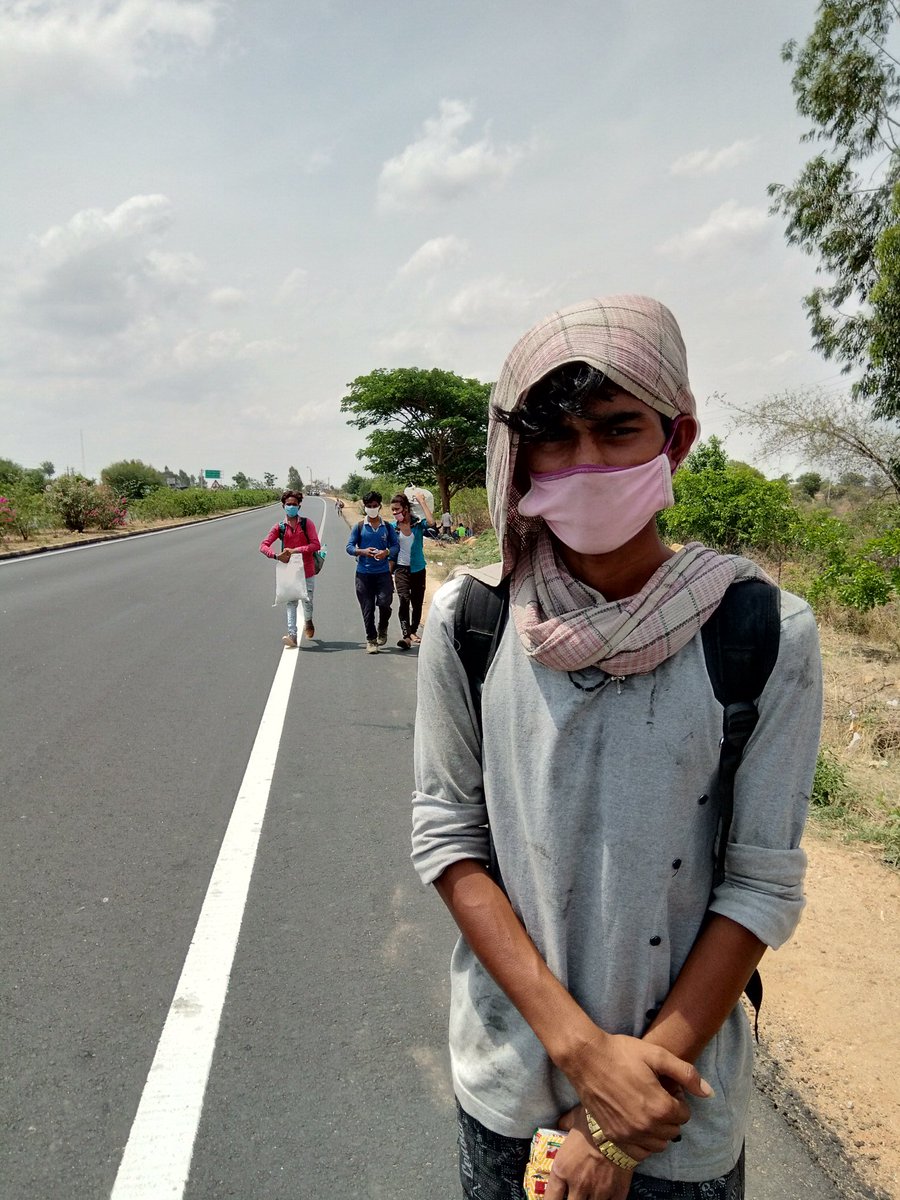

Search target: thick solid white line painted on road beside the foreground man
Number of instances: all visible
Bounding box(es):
[110,650,298,1200]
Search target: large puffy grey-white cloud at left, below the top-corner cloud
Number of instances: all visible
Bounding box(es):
[13,196,203,337]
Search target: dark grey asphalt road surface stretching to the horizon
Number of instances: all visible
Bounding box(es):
[0,498,854,1200]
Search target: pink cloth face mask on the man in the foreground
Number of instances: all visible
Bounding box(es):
[518,438,674,554]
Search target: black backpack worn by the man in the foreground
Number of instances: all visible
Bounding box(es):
[454,575,781,1040]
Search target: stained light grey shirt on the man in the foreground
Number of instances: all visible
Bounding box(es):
[413,580,822,1181]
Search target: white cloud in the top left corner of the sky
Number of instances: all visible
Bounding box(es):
[0,0,222,94]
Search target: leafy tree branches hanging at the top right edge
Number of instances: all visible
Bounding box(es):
[769,0,900,419]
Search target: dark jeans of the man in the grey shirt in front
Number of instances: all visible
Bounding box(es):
[456,1103,744,1200]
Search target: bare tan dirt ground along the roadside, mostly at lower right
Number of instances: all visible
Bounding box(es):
[8,505,900,1200]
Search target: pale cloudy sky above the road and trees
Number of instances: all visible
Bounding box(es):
[0,0,842,485]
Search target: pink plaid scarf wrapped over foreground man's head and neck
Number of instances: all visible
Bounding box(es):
[473,295,764,676]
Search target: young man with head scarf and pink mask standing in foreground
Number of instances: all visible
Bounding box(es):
[413,295,822,1200]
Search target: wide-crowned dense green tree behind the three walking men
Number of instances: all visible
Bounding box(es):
[341,367,491,511]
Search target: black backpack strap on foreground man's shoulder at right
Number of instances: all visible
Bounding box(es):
[702,580,781,1040]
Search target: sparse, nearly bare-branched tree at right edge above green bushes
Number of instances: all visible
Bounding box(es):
[724,390,900,500]
